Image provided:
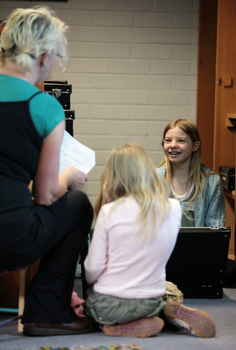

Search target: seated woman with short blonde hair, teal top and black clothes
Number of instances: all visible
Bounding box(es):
[0,7,94,336]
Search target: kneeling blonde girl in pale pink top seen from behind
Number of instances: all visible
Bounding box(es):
[85,143,216,337]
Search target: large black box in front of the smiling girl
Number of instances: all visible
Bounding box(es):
[166,226,230,299]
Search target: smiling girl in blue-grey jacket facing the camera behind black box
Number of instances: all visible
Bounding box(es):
[156,119,236,287]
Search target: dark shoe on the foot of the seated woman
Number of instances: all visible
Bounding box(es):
[23,317,97,337]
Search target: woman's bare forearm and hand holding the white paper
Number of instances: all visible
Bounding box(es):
[33,120,88,205]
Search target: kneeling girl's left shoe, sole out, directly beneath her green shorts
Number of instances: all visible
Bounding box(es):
[103,316,164,338]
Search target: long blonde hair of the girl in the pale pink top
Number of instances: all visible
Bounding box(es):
[94,143,171,239]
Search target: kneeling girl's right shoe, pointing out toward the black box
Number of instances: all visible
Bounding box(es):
[164,301,216,338]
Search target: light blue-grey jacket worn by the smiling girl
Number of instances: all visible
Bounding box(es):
[156,164,225,227]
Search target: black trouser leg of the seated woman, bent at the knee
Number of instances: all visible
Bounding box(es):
[18,191,93,323]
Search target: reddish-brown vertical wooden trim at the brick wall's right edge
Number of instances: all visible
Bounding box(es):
[196,0,218,168]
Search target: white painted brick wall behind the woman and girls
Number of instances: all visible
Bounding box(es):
[0,0,199,203]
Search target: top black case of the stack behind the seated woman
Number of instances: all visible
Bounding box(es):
[44,81,72,109]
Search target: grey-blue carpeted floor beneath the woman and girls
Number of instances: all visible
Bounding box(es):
[0,280,236,350]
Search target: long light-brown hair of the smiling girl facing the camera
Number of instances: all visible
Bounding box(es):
[156,119,215,202]
